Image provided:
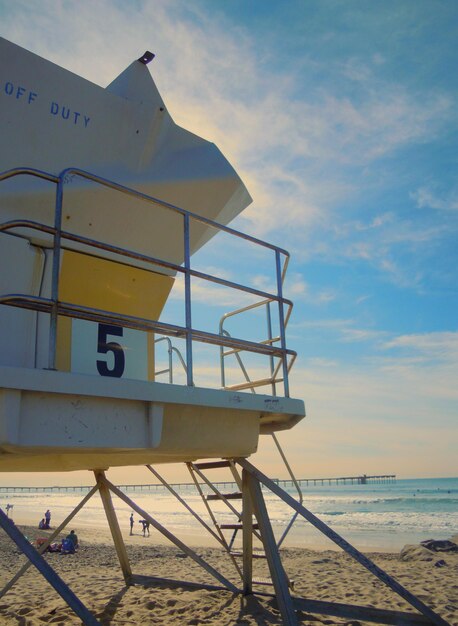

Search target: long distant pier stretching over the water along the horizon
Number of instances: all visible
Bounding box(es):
[0,474,396,494]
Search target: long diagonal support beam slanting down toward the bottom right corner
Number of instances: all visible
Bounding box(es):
[236,458,450,626]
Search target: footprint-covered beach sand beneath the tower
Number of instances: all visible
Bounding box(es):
[0,527,458,626]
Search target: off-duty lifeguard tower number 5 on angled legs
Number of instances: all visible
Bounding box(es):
[0,39,445,624]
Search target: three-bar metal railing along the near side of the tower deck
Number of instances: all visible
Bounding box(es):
[0,168,296,396]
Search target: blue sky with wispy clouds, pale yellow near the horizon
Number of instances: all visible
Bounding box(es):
[0,0,458,484]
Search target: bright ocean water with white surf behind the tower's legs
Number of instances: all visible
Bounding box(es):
[0,478,458,552]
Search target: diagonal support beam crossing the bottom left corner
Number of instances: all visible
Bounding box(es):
[0,509,101,626]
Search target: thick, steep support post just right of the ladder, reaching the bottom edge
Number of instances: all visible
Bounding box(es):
[244,471,297,626]
